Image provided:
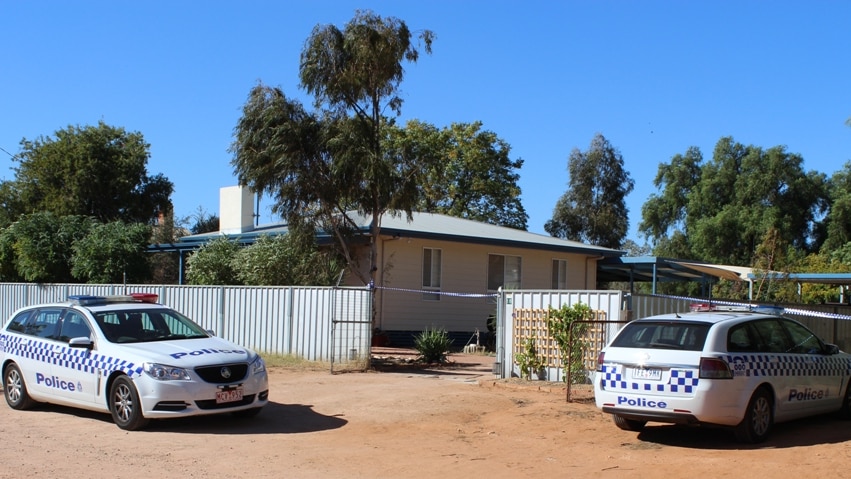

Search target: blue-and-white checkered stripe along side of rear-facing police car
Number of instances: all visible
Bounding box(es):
[723,354,851,377]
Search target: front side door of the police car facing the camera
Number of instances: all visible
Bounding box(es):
[53,309,97,404]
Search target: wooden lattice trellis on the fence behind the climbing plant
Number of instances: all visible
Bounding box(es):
[512,309,606,371]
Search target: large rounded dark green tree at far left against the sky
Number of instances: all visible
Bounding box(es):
[8,122,174,224]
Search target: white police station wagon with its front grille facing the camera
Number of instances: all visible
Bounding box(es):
[0,294,269,430]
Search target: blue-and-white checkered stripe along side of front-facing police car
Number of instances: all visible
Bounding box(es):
[3,336,142,377]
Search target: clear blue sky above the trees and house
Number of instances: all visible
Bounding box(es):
[0,0,851,243]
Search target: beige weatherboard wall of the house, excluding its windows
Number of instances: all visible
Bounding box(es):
[362,237,596,336]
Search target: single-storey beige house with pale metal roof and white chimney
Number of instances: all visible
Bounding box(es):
[160,187,623,346]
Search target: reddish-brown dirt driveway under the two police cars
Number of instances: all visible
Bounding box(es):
[0,355,851,479]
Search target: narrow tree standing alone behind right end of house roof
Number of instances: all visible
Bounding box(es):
[544,133,635,249]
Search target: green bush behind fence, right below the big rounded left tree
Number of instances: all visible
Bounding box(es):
[71,221,151,284]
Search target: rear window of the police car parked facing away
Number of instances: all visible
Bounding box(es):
[611,321,712,351]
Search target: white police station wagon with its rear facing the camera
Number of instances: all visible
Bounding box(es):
[594,304,851,443]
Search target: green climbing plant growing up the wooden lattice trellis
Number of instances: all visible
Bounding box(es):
[547,303,593,384]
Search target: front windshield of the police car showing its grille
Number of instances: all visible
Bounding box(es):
[94,308,209,343]
